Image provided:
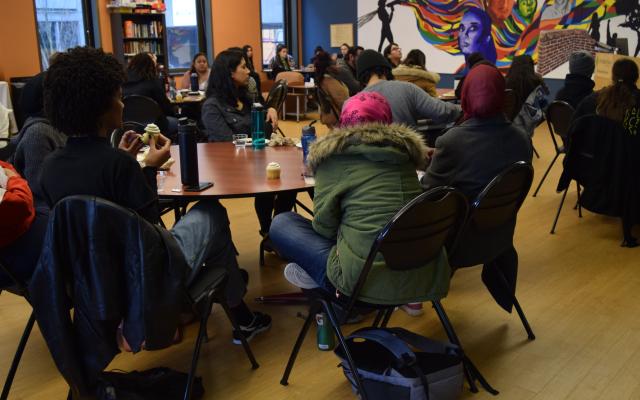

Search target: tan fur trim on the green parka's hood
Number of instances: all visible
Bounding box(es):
[307,123,427,171]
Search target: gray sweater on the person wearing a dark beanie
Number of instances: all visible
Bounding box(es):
[363,81,462,128]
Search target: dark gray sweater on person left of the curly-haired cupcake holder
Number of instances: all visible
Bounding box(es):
[11,117,67,206]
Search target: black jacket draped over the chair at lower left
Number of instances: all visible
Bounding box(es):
[29,196,189,397]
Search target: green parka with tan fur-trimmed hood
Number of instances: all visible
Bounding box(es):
[308,124,451,304]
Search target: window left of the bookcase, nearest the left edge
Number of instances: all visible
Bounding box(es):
[35,0,93,70]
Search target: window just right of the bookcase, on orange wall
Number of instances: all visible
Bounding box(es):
[165,0,205,70]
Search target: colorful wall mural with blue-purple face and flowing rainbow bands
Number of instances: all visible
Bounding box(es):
[358,0,640,77]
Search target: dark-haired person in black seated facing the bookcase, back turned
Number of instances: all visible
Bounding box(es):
[122,53,178,136]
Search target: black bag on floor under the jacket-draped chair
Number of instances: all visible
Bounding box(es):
[96,368,204,400]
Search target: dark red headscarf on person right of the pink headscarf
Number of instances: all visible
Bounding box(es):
[461,65,505,120]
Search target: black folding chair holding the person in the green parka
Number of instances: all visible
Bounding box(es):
[280,187,467,400]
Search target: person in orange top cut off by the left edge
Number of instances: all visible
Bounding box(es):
[0,161,48,289]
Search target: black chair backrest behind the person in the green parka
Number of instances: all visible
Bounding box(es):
[346,186,468,314]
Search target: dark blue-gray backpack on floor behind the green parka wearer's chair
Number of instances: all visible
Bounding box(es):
[335,328,464,400]
